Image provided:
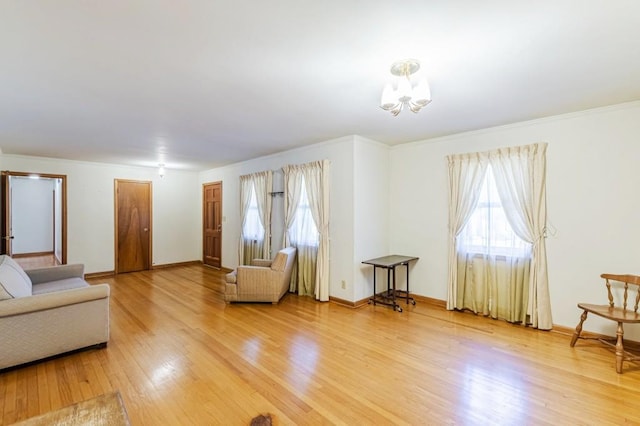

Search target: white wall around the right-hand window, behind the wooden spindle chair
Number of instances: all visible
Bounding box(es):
[390,102,640,340]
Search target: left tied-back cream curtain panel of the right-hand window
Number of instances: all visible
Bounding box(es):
[447,154,487,310]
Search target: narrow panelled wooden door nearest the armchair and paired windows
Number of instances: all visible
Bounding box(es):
[202,182,222,268]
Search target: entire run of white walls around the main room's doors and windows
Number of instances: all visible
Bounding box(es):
[6,102,640,340]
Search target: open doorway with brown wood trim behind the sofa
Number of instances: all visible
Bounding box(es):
[0,171,67,265]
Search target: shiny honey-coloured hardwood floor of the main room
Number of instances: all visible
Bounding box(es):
[0,265,640,425]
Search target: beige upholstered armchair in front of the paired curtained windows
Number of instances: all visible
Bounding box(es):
[224,247,296,304]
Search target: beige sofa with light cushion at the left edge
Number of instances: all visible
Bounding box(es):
[0,255,110,370]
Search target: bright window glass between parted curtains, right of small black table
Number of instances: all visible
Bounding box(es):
[458,166,531,257]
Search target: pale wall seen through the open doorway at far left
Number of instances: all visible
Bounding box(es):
[10,176,55,255]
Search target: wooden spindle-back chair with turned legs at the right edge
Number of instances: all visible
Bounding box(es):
[571,274,640,373]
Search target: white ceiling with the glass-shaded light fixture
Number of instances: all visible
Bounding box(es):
[0,0,640,170]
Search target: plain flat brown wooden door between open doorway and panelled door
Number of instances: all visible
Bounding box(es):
[115,179,151,274]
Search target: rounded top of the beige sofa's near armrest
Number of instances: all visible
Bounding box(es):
[0,284,110,318]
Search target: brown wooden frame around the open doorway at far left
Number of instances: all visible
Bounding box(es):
[0,170,67,265]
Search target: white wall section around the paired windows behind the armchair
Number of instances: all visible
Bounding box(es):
[199,136,354,297]
